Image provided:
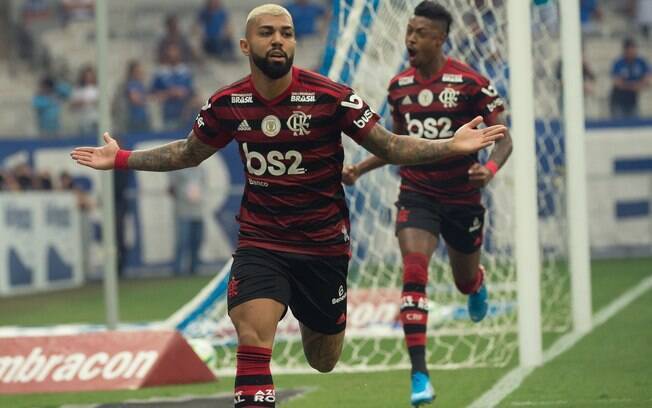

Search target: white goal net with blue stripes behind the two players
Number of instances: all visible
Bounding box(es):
[170,0,570,373]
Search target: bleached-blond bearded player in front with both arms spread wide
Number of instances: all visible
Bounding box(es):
[71,5,506,407]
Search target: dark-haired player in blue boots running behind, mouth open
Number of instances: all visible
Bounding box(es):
[343,1,512,406]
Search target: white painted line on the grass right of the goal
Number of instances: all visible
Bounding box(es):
[469,276,652,408]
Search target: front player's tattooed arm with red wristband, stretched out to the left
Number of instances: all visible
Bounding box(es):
[70,131,218,171]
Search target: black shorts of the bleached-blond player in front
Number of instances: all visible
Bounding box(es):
[227,248,349,334]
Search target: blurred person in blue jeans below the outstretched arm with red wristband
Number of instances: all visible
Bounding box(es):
[170,167,206,275]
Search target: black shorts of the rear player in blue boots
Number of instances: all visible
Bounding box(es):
[396,190,485,254]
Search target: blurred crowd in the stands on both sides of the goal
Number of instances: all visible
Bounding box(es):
[0,0,652,142]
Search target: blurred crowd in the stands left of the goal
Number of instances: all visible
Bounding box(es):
[0,0,330,138]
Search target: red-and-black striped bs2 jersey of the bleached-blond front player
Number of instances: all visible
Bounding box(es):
[193,68,379,255]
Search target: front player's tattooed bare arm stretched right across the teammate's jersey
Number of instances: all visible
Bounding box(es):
[362,116,507,165]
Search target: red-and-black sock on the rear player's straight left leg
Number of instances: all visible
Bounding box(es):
[401,253,428,372]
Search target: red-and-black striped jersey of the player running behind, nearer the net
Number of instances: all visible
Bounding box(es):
[387,58,504,204]
